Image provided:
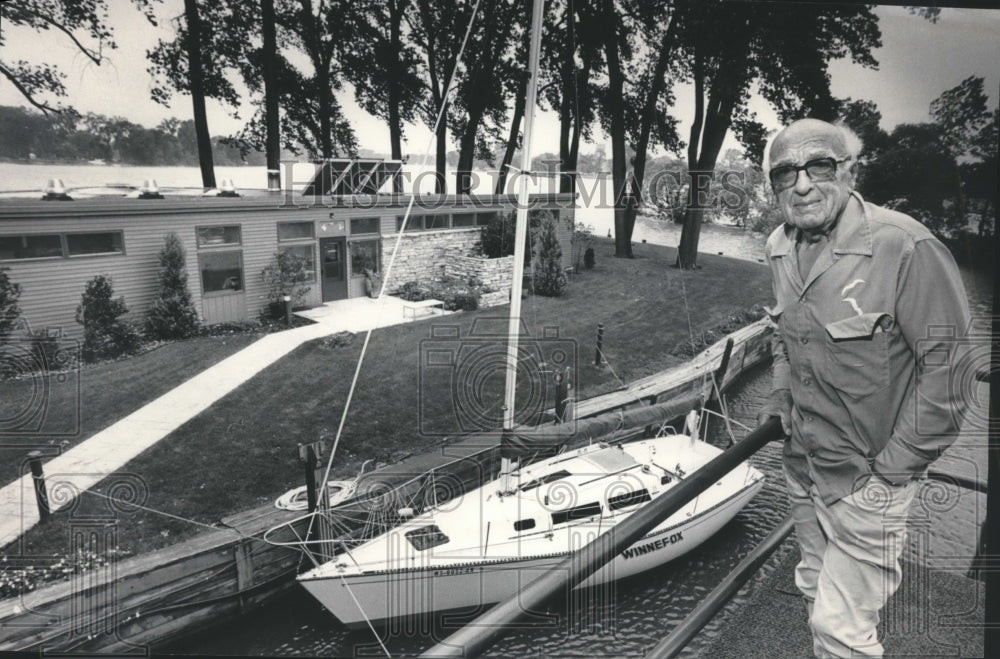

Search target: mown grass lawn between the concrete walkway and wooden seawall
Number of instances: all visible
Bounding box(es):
[5,240,771,555]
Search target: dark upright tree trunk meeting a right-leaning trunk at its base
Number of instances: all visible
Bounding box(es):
[602,0,632,258]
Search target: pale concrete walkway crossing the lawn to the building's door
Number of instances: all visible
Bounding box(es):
[0,296,450,547]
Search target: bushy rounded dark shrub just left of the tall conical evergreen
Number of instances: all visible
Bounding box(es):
[76,275,141,361]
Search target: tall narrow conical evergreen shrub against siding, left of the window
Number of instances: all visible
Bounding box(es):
[146,233,200,339]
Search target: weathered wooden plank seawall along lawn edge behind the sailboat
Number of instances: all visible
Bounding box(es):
[0,321,771,654]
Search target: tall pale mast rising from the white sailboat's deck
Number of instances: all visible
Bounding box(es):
[500,0,545,492]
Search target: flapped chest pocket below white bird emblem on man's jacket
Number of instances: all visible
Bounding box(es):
[825,312,893,398]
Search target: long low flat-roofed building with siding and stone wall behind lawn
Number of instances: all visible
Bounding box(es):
[0,160,575,336]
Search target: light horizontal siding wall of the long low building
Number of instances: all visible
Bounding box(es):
[0,191,573,336]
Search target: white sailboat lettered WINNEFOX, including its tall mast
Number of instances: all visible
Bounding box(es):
[276,2,763,627]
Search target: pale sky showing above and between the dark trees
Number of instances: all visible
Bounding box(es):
[0,0,1000,161]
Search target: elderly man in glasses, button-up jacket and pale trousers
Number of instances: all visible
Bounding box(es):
[759,119,969,657]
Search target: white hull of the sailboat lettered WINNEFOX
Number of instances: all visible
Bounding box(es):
[299,438,763,627]
